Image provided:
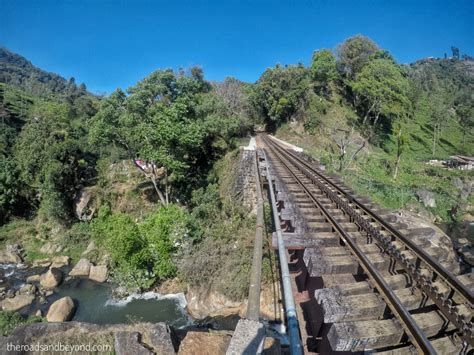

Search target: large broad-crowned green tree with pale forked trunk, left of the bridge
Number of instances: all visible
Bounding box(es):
[90,68,238,204]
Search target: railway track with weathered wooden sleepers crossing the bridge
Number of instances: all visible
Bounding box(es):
[260,135,474,354]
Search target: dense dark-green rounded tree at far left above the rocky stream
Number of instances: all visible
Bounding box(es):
[14,102,86,222]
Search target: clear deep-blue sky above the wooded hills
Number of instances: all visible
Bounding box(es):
[0,0,474,92]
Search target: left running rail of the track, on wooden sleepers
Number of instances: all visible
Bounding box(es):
[262,140,437,354]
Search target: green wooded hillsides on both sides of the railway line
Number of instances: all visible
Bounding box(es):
[0,36,474,299]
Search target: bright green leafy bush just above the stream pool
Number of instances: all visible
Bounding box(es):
[92,205,194,288]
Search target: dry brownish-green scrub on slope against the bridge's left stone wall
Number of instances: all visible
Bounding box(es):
[178,151,255,300]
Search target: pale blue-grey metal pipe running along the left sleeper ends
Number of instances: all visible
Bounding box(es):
[262,150,303,355]
